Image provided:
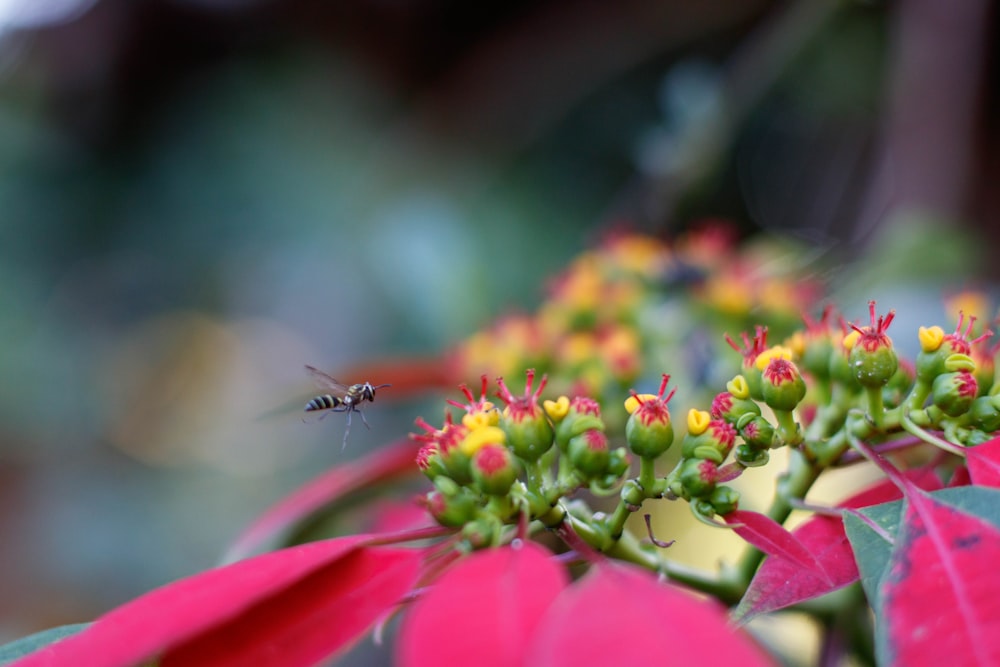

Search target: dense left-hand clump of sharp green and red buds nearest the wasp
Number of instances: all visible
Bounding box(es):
[411,370,630,545]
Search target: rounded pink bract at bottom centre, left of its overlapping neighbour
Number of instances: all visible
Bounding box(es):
[397,542,567,667]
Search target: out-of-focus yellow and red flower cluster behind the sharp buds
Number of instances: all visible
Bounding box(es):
[449,222,820,412]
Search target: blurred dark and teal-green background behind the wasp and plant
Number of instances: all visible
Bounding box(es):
[0,0,1000,640]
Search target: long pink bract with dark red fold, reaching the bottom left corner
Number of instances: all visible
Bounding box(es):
[9,536,422,667]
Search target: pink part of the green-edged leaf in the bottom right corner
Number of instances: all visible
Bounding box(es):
[879,492,1000,665]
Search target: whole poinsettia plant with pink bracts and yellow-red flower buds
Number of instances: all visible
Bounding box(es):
[0,229,1000,667]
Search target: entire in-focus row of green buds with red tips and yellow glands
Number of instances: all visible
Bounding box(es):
[413,302,1000,548]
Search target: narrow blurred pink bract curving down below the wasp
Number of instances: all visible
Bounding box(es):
[224,440,417,563]
